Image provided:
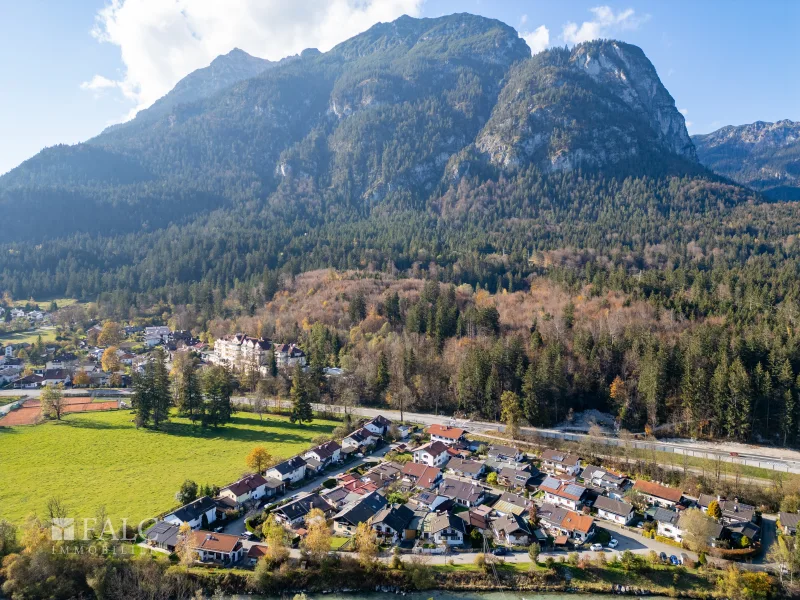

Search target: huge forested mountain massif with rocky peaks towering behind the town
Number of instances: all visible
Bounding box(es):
[0,14,752,302]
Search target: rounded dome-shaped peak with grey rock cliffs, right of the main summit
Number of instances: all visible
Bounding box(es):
[476,41,697,171]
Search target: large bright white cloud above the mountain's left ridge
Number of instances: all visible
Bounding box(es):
[81,0,423,116]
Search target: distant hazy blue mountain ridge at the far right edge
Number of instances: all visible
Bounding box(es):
[692,120,800,200]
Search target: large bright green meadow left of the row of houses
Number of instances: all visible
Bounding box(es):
[0,411,336,526]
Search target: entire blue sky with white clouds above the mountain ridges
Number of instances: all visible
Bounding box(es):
[0,0,800,173]
